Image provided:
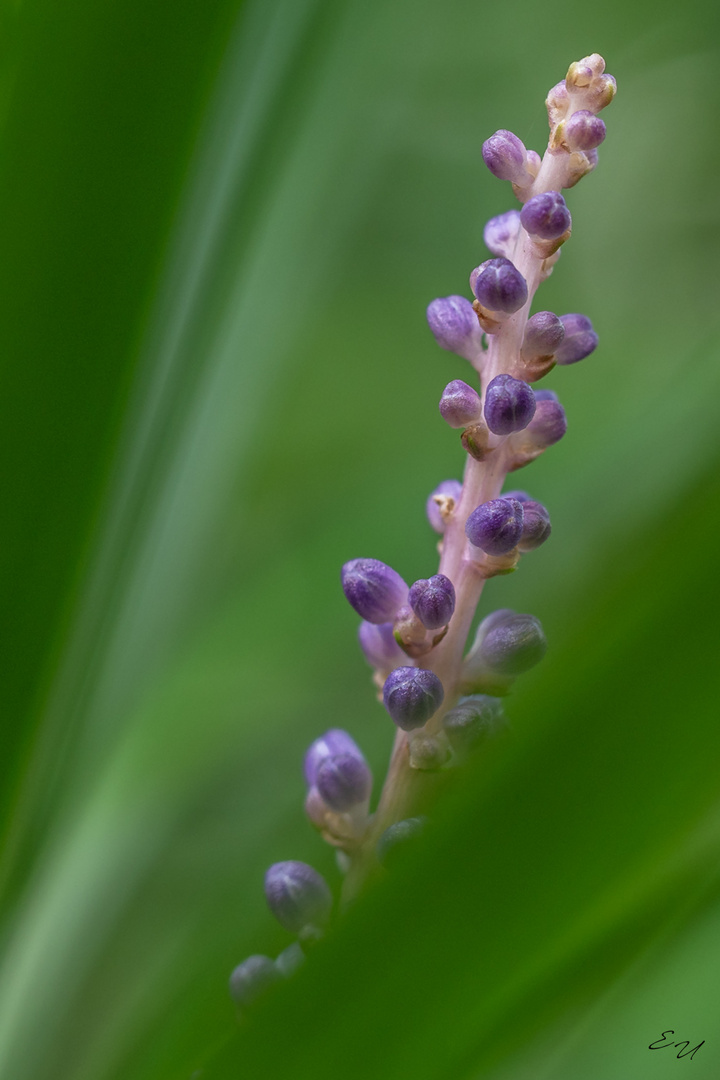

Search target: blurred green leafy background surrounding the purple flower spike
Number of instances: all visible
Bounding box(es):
[0,0,720,1080]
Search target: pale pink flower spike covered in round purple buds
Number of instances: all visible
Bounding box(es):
[231,53,615,1005]
